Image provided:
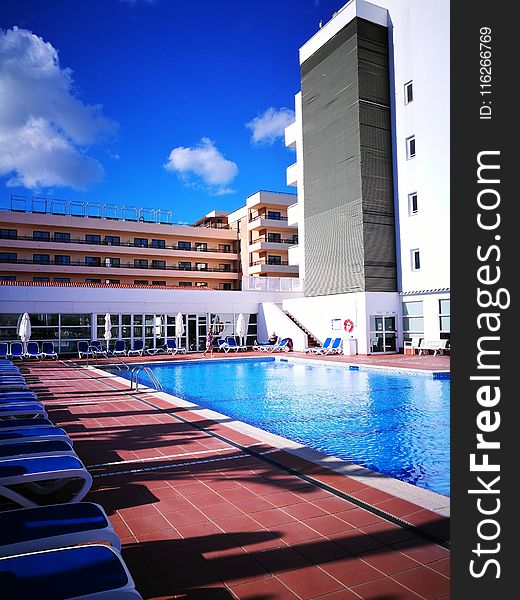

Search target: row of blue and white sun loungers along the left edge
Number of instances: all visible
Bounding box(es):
[0,359,142,600]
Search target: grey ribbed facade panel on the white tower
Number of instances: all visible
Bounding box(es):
[301,18,397,296]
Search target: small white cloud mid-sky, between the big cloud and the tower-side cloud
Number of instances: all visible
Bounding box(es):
[164,137,238,195]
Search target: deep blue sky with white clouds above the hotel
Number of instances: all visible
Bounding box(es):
[0,0,344,222]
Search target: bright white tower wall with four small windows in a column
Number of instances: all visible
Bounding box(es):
[377,0,450,292]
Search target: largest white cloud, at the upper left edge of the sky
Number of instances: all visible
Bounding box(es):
[0,27,116,189]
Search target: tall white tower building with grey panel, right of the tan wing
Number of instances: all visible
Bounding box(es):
[283,0,450,354]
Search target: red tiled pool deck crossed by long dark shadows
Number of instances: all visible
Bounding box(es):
[15,353,450,600]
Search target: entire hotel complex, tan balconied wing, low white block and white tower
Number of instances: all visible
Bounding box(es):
[0,0,450,354]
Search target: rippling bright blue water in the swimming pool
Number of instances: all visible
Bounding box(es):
[118,358,450,496]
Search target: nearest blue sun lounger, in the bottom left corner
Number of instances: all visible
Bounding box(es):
[0,544,142,600]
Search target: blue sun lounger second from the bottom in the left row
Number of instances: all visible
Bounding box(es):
[0,502,121,557]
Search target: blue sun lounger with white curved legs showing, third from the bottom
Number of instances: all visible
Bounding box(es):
[0,456,92,506]
